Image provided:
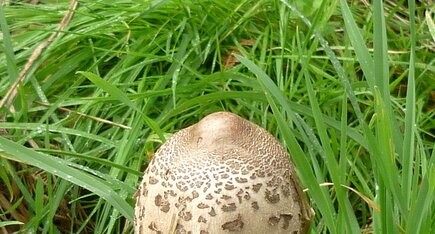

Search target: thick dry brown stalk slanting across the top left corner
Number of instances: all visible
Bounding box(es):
[0,0,78,112]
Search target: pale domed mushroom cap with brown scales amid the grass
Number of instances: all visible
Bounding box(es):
[134,112,313,234]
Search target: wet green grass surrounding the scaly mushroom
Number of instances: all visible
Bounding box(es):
[0,0,435,233]
